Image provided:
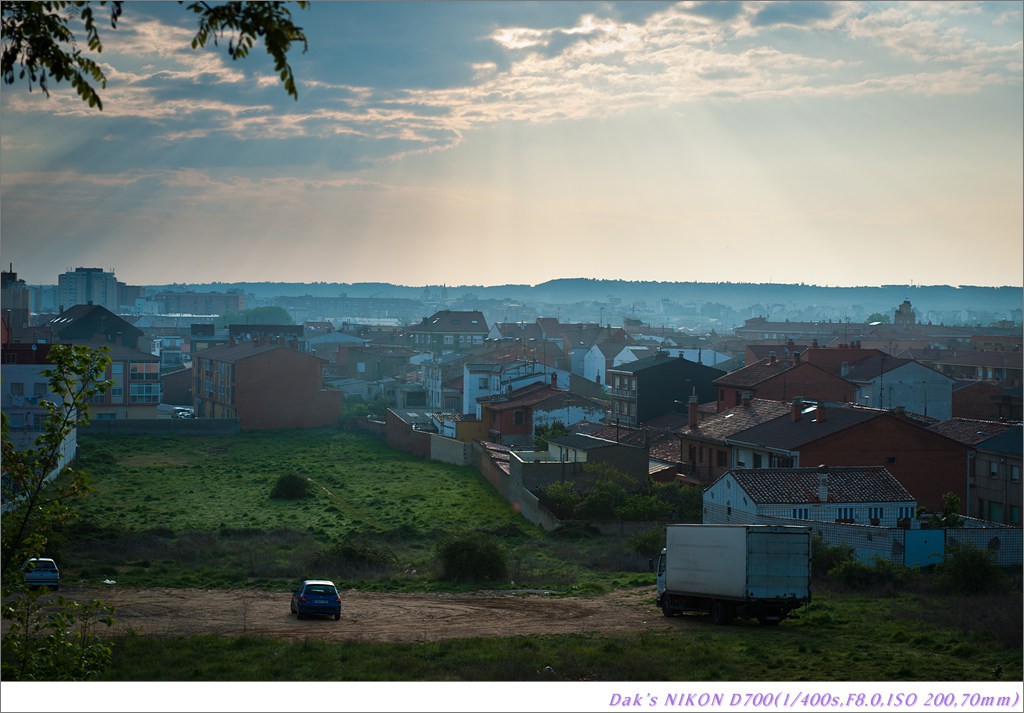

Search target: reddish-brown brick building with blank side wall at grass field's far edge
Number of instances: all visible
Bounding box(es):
[193,342,342,430]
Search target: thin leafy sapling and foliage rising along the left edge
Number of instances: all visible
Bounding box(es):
[0,344,114,680]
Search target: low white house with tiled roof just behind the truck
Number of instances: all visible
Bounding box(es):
[703,466,918,528]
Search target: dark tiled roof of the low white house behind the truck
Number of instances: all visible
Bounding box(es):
[722,465,914,504]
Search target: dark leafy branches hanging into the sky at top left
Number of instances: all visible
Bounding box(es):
[0,0,309,111]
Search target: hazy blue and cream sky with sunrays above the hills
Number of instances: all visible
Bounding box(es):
[0,0,1024,286]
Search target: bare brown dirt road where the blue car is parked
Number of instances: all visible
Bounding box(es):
[54,586,685,642]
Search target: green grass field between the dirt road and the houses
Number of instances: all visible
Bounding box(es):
[59,430,650,593]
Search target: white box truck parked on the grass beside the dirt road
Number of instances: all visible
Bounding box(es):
[656,525,811,625]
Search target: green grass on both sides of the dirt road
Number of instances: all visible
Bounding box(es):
[57,430,1022,681]
